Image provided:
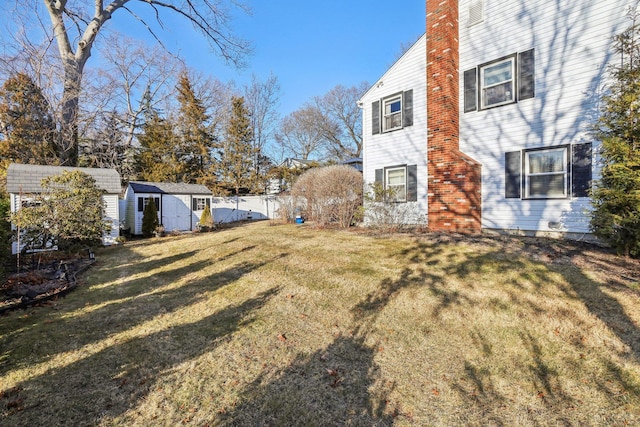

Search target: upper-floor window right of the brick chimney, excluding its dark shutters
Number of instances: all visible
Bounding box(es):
[480,57,516,108]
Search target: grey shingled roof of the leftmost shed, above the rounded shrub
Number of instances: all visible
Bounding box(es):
[7,163,122,194]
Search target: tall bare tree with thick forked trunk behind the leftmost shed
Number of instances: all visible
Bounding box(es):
[10,0,248,165]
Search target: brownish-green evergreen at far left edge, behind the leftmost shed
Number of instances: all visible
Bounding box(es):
[0,73,57,165]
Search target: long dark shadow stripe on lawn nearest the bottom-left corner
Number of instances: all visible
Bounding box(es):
[0,288,279,425]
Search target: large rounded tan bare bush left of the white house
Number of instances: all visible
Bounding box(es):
[291,165,362,228]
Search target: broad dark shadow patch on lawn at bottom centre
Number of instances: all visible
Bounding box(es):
[218,337,393,426]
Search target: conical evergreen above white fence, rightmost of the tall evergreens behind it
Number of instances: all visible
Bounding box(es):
[220,97,258,195]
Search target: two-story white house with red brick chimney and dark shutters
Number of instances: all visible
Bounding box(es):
[361,0,632,235]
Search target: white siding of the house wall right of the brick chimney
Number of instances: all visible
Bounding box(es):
[459,0,632,233]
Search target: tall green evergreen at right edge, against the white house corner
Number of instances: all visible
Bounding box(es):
[591,11,640,257]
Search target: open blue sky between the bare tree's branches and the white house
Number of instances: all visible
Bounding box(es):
[108,0,425,116]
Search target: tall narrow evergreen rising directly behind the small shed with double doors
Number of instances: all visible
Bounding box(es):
[177,74,216,183]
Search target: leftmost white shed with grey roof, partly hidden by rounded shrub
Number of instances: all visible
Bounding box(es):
[7,163,122,254]
